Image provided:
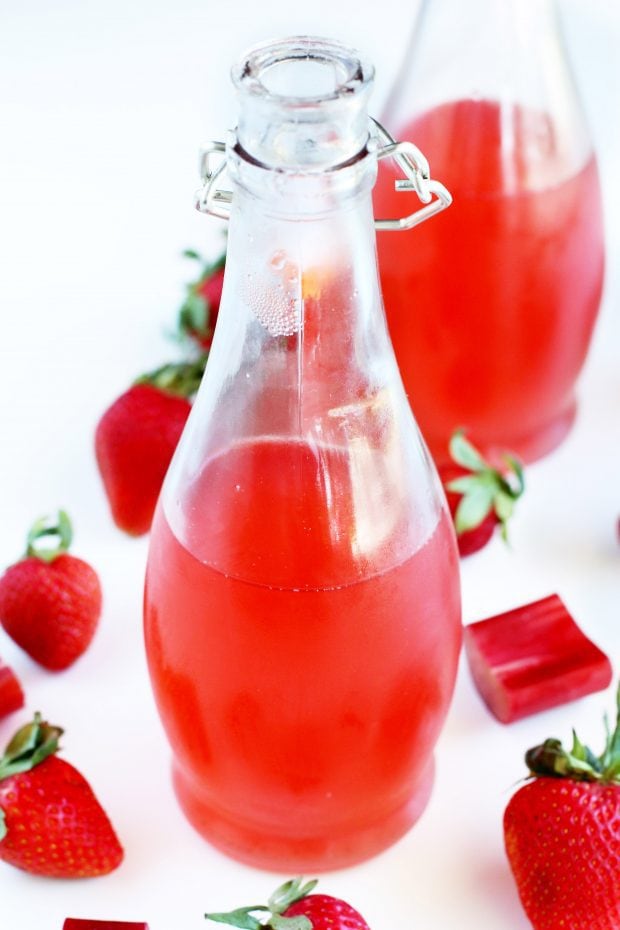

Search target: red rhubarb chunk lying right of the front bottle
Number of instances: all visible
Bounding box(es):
[464,594,612,723]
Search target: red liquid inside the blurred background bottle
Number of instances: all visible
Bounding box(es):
[375,100,604,461]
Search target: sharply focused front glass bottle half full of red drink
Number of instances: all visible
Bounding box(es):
[145,38,461,871]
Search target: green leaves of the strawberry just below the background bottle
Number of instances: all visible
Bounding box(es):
[446,430,525,541]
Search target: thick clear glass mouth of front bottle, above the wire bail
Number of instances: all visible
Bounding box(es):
[232,36,374,171]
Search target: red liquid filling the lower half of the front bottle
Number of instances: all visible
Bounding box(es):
[145,439,461,870]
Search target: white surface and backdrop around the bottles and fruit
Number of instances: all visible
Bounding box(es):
[0,0,620,930]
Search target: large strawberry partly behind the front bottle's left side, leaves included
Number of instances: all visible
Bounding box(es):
[95,355,206,536]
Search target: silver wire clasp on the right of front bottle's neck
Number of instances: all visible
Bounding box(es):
[370,117,452,231]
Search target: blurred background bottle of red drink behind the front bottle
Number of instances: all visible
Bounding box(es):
[375,0,604,461]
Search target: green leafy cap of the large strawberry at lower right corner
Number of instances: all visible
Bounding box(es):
[525,685,620,785]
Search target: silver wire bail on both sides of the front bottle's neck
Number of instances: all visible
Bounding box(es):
[195,117,452,231]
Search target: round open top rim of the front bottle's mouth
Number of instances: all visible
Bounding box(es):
[232,36,374,108]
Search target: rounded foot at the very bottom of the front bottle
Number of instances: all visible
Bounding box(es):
[172,758,435,874]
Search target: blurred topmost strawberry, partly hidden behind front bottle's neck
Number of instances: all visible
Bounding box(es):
[179,249,226,351]
